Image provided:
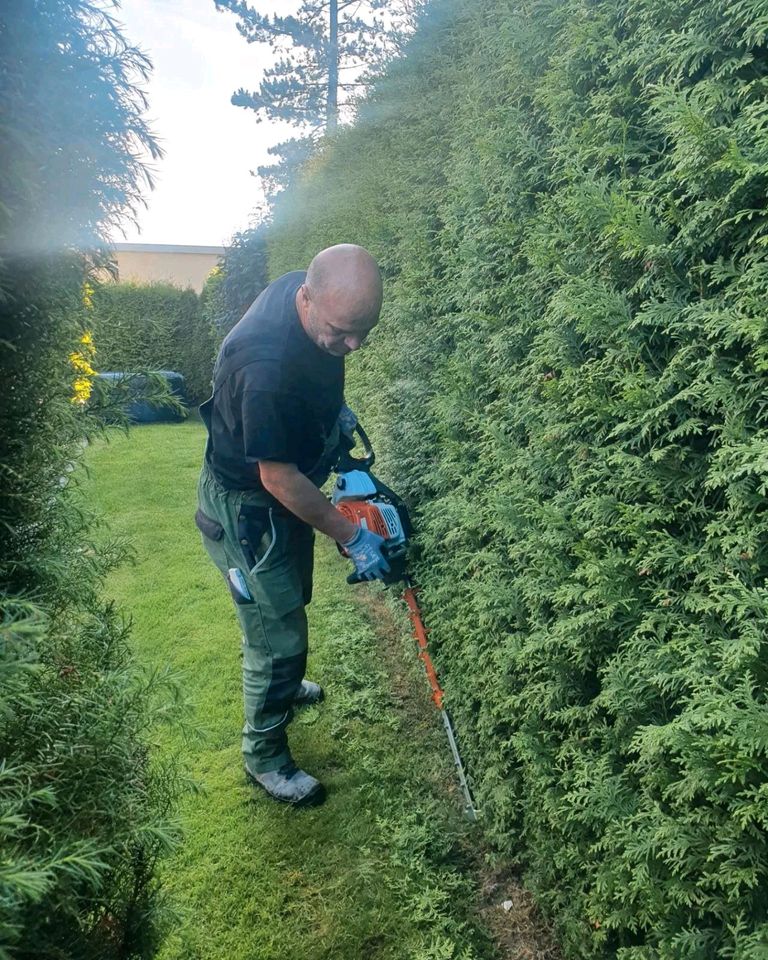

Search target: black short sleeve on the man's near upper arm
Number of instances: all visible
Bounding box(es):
[242,390,303,463]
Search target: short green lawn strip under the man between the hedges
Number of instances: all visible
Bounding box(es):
[85,421,496,960]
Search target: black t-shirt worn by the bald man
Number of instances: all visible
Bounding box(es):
[200,271,344,490]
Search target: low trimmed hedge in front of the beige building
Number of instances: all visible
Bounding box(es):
[92,283,214,403]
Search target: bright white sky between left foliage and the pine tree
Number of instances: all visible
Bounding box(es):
[112,0,290,246]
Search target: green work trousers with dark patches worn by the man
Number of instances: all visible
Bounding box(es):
[196,464,314,773]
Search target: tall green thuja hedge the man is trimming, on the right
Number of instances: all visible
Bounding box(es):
[270,0,768,960]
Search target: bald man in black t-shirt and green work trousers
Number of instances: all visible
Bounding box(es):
[195,244,389,806]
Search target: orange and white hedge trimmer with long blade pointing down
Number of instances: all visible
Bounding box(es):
[331,423,478,820]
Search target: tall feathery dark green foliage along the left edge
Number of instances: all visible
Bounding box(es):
[0,0,182,960]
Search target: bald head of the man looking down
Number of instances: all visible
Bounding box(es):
[296,243,383,356]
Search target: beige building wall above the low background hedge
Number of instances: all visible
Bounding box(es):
[114,243,224,293]
